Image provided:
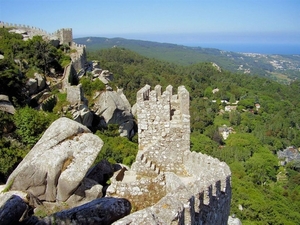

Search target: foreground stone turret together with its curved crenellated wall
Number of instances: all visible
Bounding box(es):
[107,85,231,225]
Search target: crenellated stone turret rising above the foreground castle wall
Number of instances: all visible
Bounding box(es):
[132,85,190,175]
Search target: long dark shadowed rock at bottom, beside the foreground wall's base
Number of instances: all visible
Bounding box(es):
[40,198,131,225]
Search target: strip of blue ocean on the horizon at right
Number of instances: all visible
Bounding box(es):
[186,43,300,55]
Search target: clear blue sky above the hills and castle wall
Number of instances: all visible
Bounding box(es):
[0,0,300,44]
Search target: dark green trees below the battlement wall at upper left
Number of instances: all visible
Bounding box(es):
[0,28,70,105]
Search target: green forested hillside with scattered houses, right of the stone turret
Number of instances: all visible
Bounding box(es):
[89,48,300,224]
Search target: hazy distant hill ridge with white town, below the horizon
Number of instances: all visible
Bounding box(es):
[74,37,300,83]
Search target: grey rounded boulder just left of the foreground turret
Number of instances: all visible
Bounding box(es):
[93,89,134,138]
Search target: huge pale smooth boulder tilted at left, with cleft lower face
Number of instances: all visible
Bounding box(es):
[7,118,103,202]
